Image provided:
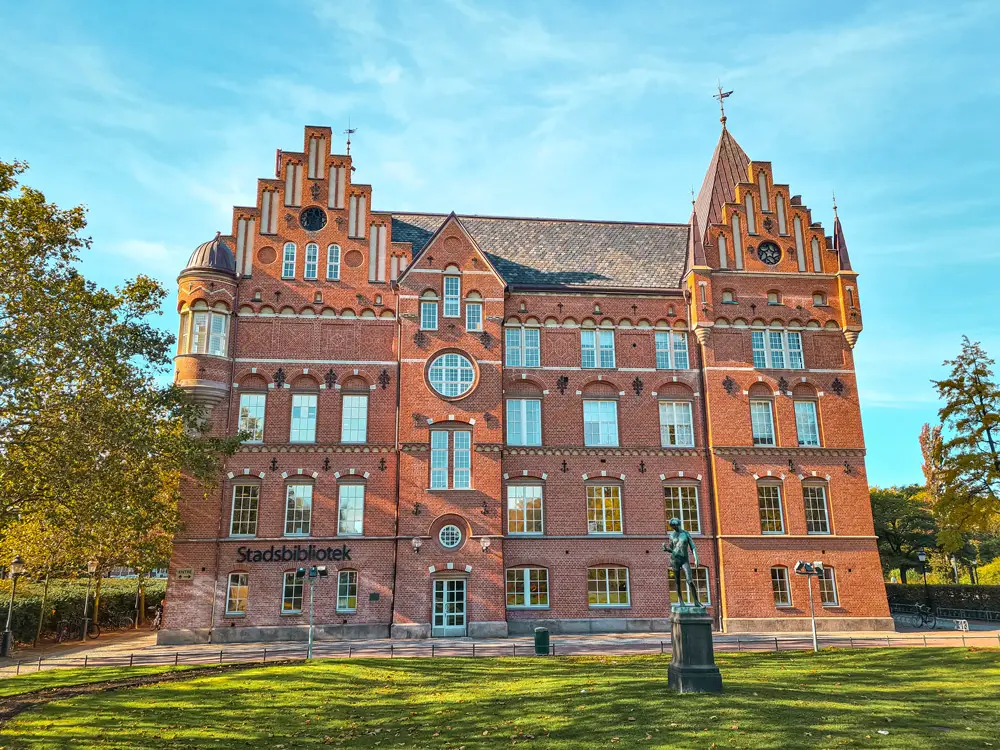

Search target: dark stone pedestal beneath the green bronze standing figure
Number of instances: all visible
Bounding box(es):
[667,606,722,693]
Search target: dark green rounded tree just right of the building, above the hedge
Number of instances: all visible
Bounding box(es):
[871,484,937,583]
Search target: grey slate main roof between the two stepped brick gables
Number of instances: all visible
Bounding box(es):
[391,212,689,289]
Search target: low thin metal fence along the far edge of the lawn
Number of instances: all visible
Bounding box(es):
[0,633,1000,677]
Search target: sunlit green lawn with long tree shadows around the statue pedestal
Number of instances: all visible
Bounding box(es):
[0,649,1000,750]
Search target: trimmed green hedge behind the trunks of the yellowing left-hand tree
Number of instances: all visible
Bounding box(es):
[0,578,167,643]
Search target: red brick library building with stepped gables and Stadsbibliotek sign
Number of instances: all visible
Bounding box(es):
[160,121,892,642]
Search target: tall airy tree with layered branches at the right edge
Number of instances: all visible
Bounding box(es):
[921,337,1000,551]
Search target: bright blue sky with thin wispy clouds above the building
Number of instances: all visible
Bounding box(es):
[0,0,1000,484]
